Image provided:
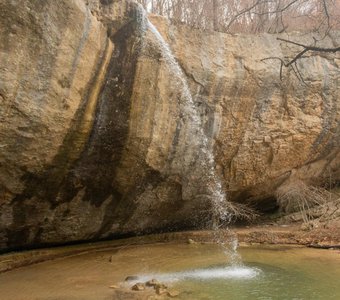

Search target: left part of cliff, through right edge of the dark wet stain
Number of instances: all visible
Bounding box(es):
[0,0,146,248]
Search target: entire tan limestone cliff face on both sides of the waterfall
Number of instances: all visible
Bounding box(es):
[0,0,340,249]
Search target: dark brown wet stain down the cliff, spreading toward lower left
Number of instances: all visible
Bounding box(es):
[7,4,143,248]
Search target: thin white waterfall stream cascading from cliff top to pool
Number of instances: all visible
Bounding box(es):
[146,18,240,265]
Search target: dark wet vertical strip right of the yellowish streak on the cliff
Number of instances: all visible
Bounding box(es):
[69,18,145,207]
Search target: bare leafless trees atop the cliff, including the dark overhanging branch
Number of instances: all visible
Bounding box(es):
[137,0,340,81]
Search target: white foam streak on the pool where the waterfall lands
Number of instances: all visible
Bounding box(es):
[129,266,261,283]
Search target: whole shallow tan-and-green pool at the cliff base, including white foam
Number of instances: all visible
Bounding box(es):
[0,244,340,300]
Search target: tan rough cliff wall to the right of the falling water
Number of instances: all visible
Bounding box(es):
[149,17,340,206]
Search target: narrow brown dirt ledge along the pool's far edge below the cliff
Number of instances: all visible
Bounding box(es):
[0,224,340,273]
